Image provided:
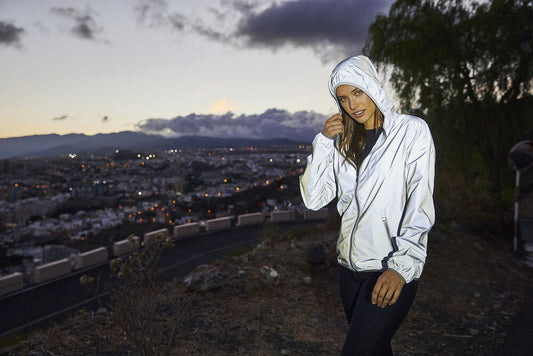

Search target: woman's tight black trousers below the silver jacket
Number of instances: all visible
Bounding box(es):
[339,266,418,356]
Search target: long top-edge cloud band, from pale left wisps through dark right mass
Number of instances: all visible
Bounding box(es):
[131,0,394,61]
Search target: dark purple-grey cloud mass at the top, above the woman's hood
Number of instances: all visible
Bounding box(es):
[236,0,393,54]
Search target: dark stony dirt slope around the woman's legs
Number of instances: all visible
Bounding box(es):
[3,221,533,355]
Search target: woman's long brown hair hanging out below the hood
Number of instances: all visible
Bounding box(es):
[339,106,383,168]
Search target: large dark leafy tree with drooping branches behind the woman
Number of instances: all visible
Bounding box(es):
[363,0,533,200]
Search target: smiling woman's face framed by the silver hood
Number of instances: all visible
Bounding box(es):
[335,85,376,130]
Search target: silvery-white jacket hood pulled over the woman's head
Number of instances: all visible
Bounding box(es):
[329,56,394,127]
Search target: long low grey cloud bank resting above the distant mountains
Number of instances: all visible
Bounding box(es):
[136,109,326,142]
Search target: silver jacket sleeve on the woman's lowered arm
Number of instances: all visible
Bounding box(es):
[387,121,435,283]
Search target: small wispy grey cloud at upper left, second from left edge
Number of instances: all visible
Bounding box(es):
[50,7,108,43]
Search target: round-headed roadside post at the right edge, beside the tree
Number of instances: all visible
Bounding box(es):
[509,141,533,251]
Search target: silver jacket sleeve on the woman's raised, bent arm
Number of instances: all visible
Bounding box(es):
[300,133,337,210]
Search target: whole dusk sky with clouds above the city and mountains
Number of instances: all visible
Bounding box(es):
[0,0,393,139]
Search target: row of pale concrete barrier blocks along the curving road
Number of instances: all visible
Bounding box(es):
[0,209,328,297]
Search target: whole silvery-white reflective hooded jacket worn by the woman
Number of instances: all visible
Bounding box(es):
[300,56,435,283]
